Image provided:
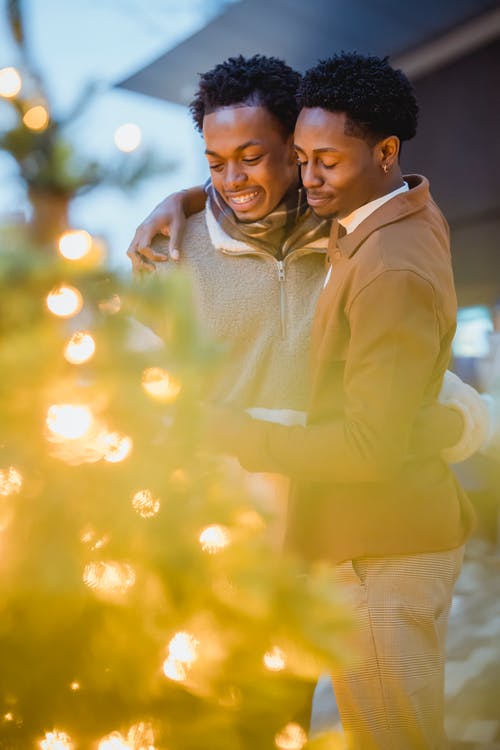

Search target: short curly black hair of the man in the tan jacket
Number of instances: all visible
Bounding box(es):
[298,52,418,143]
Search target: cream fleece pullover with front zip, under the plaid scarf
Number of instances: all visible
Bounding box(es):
[154,209,327,423]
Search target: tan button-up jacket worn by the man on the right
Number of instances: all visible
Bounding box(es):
[221,176,473,561]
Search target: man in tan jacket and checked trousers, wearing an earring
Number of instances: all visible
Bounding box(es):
[209,54,473,750]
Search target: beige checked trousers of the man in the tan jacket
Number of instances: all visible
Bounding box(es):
[332,548,463,750]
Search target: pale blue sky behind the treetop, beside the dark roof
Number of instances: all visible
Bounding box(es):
[0,0,234,265]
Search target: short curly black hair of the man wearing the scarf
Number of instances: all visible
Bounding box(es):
[189,55,300,136]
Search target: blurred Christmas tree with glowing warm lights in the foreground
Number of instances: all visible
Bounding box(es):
[0,2,347,750]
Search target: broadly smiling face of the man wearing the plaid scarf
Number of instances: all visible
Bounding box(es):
[203,105,298,222]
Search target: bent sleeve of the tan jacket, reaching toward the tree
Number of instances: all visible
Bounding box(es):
[209,270,448,482]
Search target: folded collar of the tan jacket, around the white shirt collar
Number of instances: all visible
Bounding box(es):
[328,175,430,258]
